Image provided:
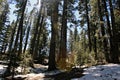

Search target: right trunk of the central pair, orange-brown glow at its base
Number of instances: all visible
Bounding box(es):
[59,0,68,69]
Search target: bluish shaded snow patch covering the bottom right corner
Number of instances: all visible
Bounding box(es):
[71,64,120,80]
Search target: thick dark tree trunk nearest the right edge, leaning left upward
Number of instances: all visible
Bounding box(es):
[108,0,119,63]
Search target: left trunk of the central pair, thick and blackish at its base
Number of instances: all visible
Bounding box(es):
[48,0,58,71]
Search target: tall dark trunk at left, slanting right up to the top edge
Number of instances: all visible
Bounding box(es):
[10,0,27,78]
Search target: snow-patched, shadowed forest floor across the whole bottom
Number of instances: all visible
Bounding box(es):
[0,64,120,80]
